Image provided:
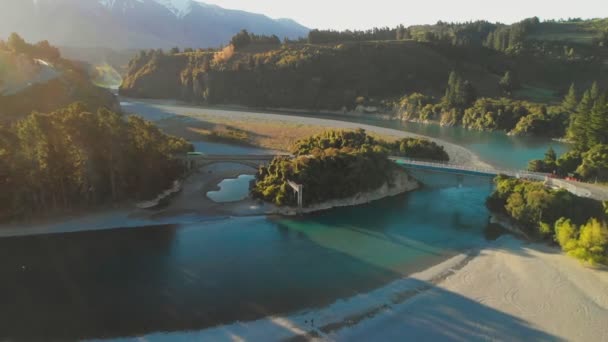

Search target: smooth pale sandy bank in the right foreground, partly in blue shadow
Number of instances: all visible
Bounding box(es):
[126,236,608,341]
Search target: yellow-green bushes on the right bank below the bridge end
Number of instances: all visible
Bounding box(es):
[487,175,608,264]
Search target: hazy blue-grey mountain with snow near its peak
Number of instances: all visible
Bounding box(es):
[0,0,308,49]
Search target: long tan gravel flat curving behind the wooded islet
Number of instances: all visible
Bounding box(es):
[121,98,492,168]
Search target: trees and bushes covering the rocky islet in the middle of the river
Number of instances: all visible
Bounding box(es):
[252,130,448,206]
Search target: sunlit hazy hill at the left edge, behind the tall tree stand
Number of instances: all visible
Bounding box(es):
[0,34,120,123]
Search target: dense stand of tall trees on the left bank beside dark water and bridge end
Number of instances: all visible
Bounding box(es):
[0,103,192,219]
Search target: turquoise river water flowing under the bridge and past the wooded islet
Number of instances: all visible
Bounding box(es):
[0,103,564,340]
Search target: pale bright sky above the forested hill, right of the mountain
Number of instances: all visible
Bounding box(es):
[202,0,608,29]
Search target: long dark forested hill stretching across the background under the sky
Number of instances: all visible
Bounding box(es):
[121,18,608,109]
